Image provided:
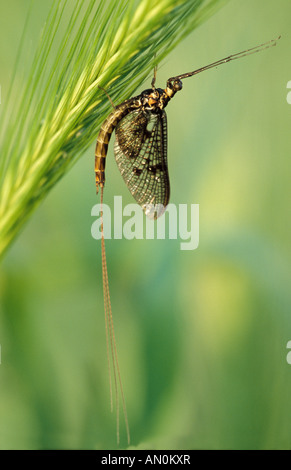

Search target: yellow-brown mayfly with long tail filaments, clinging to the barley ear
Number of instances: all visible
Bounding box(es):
[95,36,280,442]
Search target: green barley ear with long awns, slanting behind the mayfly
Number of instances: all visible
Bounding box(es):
[0,0,226,256]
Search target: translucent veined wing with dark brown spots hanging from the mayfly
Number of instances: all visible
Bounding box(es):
[114,109,170,218]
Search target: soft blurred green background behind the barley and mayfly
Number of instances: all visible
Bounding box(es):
[0,0,291,449]
